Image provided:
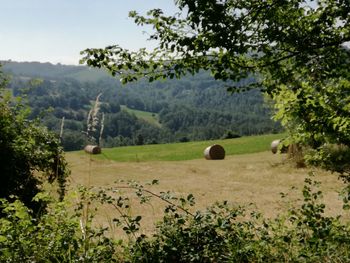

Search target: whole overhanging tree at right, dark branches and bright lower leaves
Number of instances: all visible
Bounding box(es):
[82,0,350,176]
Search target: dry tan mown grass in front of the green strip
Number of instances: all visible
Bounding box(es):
[67,152,348,238]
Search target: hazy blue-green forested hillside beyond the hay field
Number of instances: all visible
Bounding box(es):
[4,62,281,150]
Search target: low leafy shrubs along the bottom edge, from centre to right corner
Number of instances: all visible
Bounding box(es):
[125,174,350,262]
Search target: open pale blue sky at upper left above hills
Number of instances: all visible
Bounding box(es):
[0,0,177,65]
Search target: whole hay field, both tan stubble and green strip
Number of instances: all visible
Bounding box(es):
[67,135,343,237]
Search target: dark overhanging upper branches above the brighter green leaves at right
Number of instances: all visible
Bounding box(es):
[83,0,350,90]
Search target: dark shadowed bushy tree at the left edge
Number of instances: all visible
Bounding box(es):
[0,68,68,215]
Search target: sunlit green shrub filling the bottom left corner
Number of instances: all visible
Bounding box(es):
[0,196,117,263]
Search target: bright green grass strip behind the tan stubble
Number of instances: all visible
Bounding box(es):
[87,134,283,162]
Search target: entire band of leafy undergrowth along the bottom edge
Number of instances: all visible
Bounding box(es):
[0,174,350,262]
